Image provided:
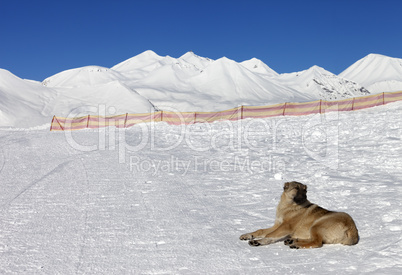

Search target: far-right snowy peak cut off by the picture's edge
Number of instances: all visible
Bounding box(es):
[339,54,402,93]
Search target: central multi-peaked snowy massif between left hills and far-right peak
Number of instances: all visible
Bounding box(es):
[113,51,380,111]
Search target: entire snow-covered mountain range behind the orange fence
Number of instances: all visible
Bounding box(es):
[0,51,402,127]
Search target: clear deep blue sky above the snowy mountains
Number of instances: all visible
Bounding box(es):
[0,0,402,81]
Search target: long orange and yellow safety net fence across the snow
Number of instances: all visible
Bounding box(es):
[50,91,402,131]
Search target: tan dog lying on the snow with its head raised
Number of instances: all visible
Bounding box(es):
[240,181,359,249]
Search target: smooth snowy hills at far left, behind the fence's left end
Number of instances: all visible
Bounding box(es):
[0,69,155,128]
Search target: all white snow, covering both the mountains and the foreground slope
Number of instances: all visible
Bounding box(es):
[0,51,402,274]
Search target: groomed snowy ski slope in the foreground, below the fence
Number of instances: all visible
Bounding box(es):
[0,103,402,274]
